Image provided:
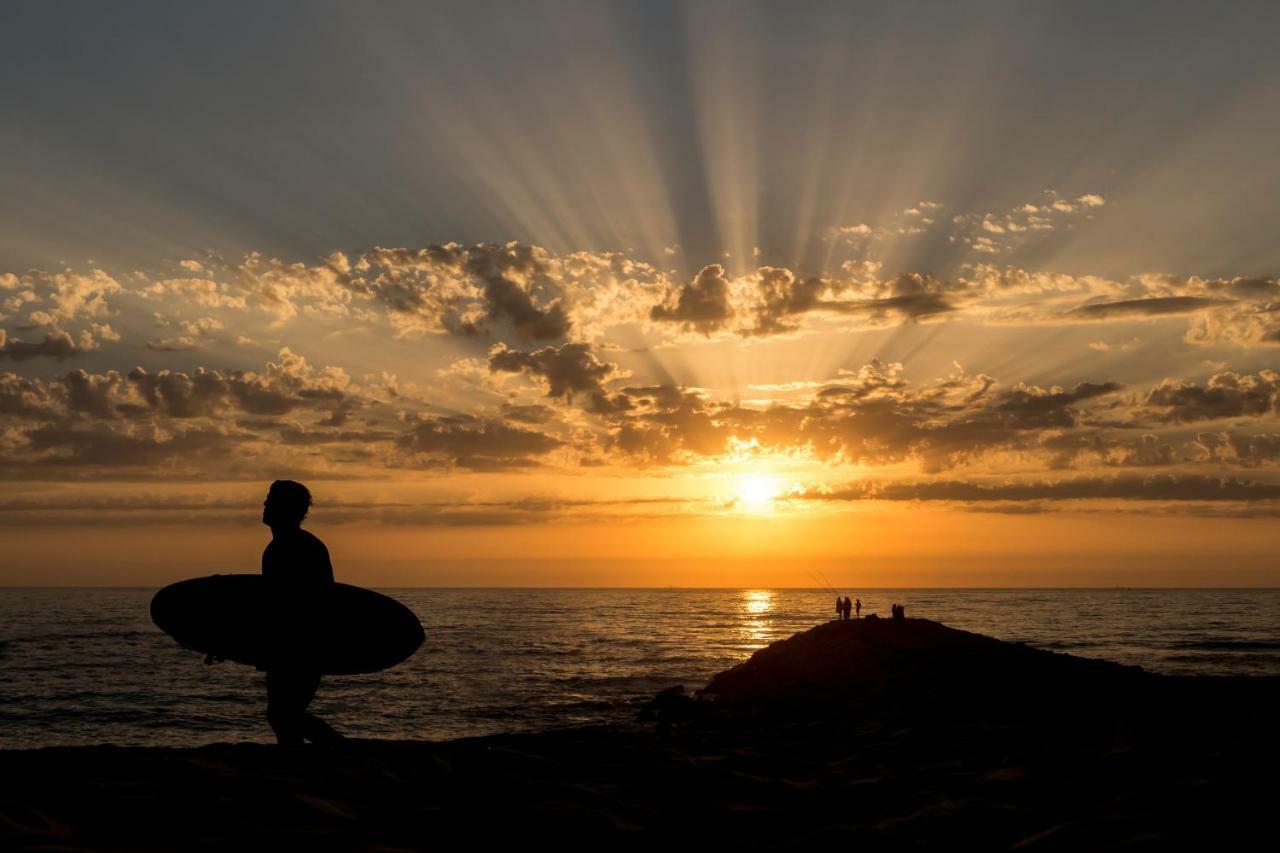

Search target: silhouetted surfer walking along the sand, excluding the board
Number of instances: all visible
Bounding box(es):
[262,480,340,747]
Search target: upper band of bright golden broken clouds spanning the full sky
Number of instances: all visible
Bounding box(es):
[10,239,1280,351]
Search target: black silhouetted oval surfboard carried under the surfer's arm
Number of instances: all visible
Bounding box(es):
[151,575,426,675]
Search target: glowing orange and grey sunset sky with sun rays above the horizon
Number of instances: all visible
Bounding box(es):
[0,1,1280,588]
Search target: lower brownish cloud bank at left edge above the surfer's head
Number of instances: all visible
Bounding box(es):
[0,348,389,479]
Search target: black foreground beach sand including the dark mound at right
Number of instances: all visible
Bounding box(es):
[0,620,1280,850]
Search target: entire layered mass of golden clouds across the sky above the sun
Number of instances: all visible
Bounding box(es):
[0,222,1280,494]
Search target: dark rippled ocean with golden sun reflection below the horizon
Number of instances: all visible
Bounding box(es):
[0,589,1280,749]
